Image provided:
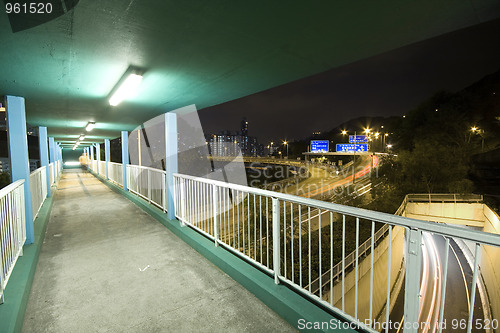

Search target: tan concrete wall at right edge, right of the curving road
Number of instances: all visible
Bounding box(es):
[479,205,500,318]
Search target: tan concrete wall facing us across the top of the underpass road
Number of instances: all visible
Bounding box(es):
[405,202,484,227]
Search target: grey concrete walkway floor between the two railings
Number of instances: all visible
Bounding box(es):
[23,169,295,332]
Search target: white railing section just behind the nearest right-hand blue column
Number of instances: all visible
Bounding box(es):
[127,164,167,211]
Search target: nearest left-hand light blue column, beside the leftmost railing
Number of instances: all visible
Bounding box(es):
[5,96,35,244]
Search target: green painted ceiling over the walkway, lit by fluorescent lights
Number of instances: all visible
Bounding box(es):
[0,0,500,147]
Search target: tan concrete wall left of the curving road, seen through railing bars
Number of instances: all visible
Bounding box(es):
[324,227,404,321]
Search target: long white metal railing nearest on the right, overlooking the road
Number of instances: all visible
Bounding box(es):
[174,174,500,333]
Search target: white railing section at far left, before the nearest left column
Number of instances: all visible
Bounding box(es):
[0,180,26,304]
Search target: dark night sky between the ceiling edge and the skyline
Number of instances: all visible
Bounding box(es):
[199,20,500,143]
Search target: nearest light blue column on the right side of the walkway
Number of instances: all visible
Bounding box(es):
[165,112,178,220]
